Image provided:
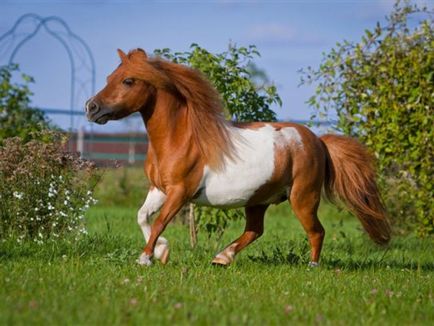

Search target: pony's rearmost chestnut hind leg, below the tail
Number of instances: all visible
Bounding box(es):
[289,182,325,267]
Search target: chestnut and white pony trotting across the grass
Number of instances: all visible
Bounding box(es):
[85,49,391,267]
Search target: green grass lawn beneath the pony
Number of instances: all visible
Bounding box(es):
[0,205,434,325]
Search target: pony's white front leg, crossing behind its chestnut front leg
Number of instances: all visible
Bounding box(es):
[137,187,169,264]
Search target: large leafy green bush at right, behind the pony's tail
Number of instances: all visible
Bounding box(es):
[302,1,434,234]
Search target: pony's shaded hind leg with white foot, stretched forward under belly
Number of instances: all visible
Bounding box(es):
[212,205,268,266]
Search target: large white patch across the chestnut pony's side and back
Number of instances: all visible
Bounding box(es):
[193,124,303,208]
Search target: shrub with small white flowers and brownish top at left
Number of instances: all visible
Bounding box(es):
[0,131,98,243]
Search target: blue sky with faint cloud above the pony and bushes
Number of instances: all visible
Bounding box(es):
[0,0,434,132]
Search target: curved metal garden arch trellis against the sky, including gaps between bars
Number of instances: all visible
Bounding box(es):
[0,13,95,131]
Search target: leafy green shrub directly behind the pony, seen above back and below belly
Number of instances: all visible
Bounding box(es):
[154,44,282,237]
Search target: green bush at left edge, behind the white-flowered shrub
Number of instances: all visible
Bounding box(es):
[0,65,50,143]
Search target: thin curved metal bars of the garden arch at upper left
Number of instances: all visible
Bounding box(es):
[0,13,95,131]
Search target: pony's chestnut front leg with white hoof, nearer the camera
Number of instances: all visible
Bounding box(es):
[139,187,187,266]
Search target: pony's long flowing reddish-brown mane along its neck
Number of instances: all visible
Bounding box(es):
[128,50,233,169]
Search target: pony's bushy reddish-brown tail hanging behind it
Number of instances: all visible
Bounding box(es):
[320,135,391,244]
